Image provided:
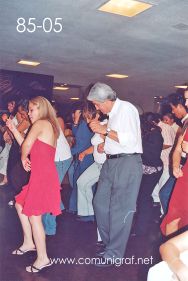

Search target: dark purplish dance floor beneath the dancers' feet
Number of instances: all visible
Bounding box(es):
[0,182,161,281]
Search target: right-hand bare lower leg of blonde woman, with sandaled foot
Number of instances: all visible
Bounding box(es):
[26,216,50,272]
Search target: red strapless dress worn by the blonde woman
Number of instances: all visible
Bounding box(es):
[15,139,61,216]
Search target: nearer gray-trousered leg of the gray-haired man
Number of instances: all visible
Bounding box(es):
[101,155,143,258]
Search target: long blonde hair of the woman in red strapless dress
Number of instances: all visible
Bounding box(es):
[29,96,59,139]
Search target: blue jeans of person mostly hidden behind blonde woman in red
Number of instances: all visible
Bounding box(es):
[42,157,72,235]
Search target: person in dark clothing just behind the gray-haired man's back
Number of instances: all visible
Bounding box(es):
[133,113,163,235]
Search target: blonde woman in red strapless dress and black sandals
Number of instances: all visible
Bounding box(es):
[7,97,61,273]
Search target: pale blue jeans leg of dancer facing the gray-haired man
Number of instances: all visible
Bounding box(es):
[77,162,100,216]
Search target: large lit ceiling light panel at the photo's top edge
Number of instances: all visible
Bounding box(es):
[99,0,152,17]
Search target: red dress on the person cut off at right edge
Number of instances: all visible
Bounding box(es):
[161,129,188,235]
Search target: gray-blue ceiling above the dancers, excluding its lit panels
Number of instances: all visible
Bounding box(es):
[0,0,188,110]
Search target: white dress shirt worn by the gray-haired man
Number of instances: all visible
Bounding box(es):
[104,99,142,154]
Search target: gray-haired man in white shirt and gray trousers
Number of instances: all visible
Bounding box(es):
[87,83,142,267]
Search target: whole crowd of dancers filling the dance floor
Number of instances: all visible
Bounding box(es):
[0,83,188,281]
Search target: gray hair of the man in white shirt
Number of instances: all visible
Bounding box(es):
[87,82,116,102]
